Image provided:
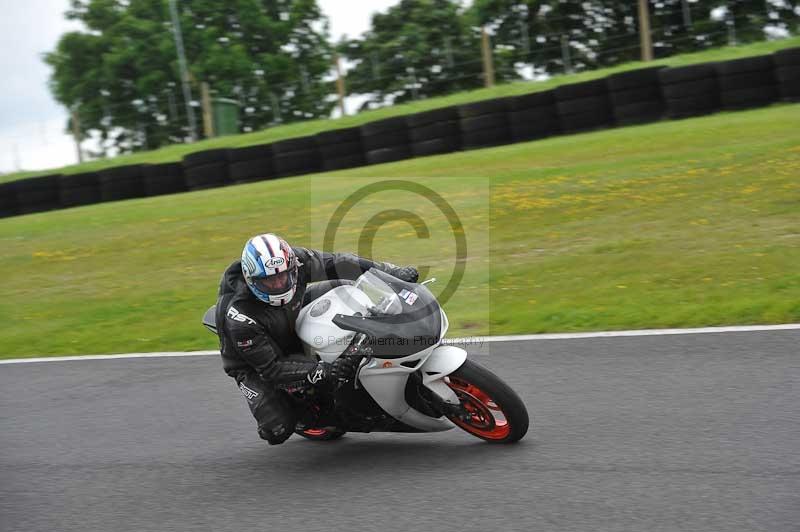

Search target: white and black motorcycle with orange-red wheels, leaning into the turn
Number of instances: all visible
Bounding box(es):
[203,268,529,443]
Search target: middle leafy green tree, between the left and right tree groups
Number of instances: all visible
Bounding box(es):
[339,0,483,106]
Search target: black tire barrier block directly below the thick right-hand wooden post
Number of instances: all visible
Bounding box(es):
[607,67,664,125]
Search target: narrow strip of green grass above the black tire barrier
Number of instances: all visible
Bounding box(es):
[0,37,800,183]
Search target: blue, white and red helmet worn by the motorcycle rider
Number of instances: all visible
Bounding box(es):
[242,233,298,307]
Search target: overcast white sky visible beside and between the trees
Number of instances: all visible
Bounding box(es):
[0,0,398,173]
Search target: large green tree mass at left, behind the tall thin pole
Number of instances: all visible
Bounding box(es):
[45,0,333,152]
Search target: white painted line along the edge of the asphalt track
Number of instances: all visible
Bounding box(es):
[0,323,800,365]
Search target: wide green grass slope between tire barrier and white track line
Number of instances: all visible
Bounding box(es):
[0,101,800,357]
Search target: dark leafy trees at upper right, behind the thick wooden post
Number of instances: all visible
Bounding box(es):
[469,0,800,73]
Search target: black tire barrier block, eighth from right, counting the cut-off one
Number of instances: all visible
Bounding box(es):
[406,107,461,157]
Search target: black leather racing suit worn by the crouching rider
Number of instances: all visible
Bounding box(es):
[216,247,412,444]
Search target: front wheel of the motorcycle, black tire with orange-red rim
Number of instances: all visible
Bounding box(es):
[448,359,530,443]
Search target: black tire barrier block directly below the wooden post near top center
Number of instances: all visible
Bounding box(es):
[458,98,511,149]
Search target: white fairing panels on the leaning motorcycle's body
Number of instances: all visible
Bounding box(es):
[296,285,467,432]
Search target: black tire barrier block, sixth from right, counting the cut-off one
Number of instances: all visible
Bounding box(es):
[508,90,561,142]
